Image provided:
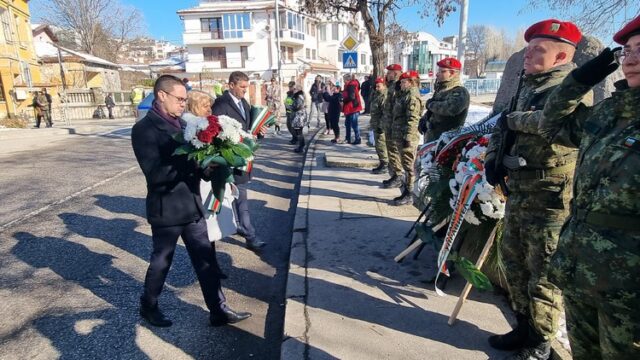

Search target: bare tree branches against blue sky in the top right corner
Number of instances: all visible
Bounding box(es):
[523,0,640,35]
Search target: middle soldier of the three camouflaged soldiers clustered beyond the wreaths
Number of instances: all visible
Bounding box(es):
[382,64,402,188]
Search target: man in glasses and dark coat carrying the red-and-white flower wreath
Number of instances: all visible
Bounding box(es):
[131,75,251,327]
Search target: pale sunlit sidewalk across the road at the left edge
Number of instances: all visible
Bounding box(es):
[0,117,135,157]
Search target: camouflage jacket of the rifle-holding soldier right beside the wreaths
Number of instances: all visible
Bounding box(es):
[487,63,593,193]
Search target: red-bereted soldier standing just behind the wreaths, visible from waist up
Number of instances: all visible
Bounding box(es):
[424,58,470,142]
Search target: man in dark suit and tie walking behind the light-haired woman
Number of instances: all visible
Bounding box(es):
[211,71,266,251]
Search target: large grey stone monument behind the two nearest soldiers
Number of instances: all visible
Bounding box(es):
[493,35,623,112]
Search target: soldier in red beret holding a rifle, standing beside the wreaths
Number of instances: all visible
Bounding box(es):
[485,19,591,359]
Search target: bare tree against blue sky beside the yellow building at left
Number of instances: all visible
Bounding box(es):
[38,0,144,60]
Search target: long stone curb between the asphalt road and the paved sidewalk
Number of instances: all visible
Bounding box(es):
[280,127,323,360]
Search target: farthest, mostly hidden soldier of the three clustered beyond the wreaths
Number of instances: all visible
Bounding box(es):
[370,77,389,174]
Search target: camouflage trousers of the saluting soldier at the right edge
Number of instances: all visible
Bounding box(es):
[564,291,640,360]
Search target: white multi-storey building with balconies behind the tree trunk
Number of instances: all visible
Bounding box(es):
[178,0,373,85]
